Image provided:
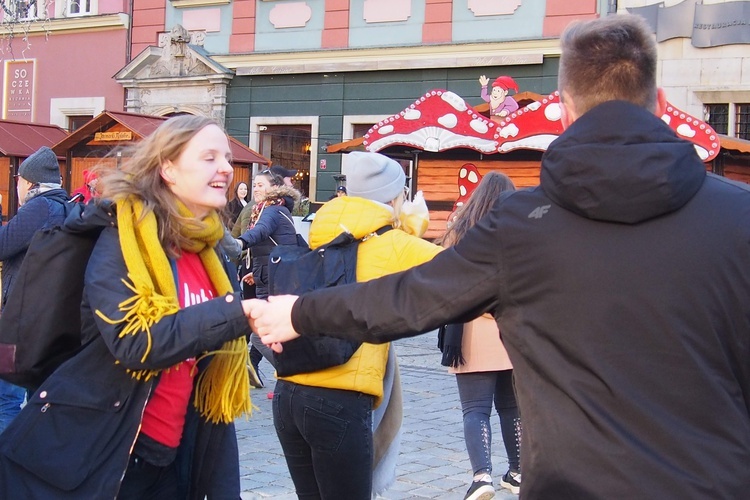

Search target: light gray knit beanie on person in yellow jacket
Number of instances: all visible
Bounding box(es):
[346,151,406,203]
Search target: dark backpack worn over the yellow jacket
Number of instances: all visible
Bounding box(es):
[268,226,391,377]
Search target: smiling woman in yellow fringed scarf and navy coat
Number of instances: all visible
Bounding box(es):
[0,116,251,499]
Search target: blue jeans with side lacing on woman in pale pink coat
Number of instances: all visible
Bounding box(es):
[456,370,521,475]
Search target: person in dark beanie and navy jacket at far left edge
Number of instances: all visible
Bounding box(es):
[0,146,69,432]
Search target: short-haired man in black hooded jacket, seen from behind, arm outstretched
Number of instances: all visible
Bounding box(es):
[253,15,750,499]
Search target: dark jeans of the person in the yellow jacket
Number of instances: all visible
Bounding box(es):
[273,380,374,500]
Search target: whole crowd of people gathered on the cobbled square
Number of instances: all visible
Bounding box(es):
[0,16,750,500]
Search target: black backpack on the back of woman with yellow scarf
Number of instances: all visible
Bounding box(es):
[0,203,103,391]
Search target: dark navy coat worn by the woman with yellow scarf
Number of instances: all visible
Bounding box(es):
[0,205,250,499]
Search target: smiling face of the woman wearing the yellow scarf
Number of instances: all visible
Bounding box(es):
[162,124,234,218]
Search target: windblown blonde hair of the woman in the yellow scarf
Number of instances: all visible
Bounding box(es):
[94,115,223,257]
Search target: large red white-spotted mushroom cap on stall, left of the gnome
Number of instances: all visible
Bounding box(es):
[363,89,497,153]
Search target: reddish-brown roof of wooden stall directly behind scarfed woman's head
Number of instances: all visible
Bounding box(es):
[52,111,271,165]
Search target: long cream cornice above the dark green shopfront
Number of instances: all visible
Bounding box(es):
[211,38,560,76]
